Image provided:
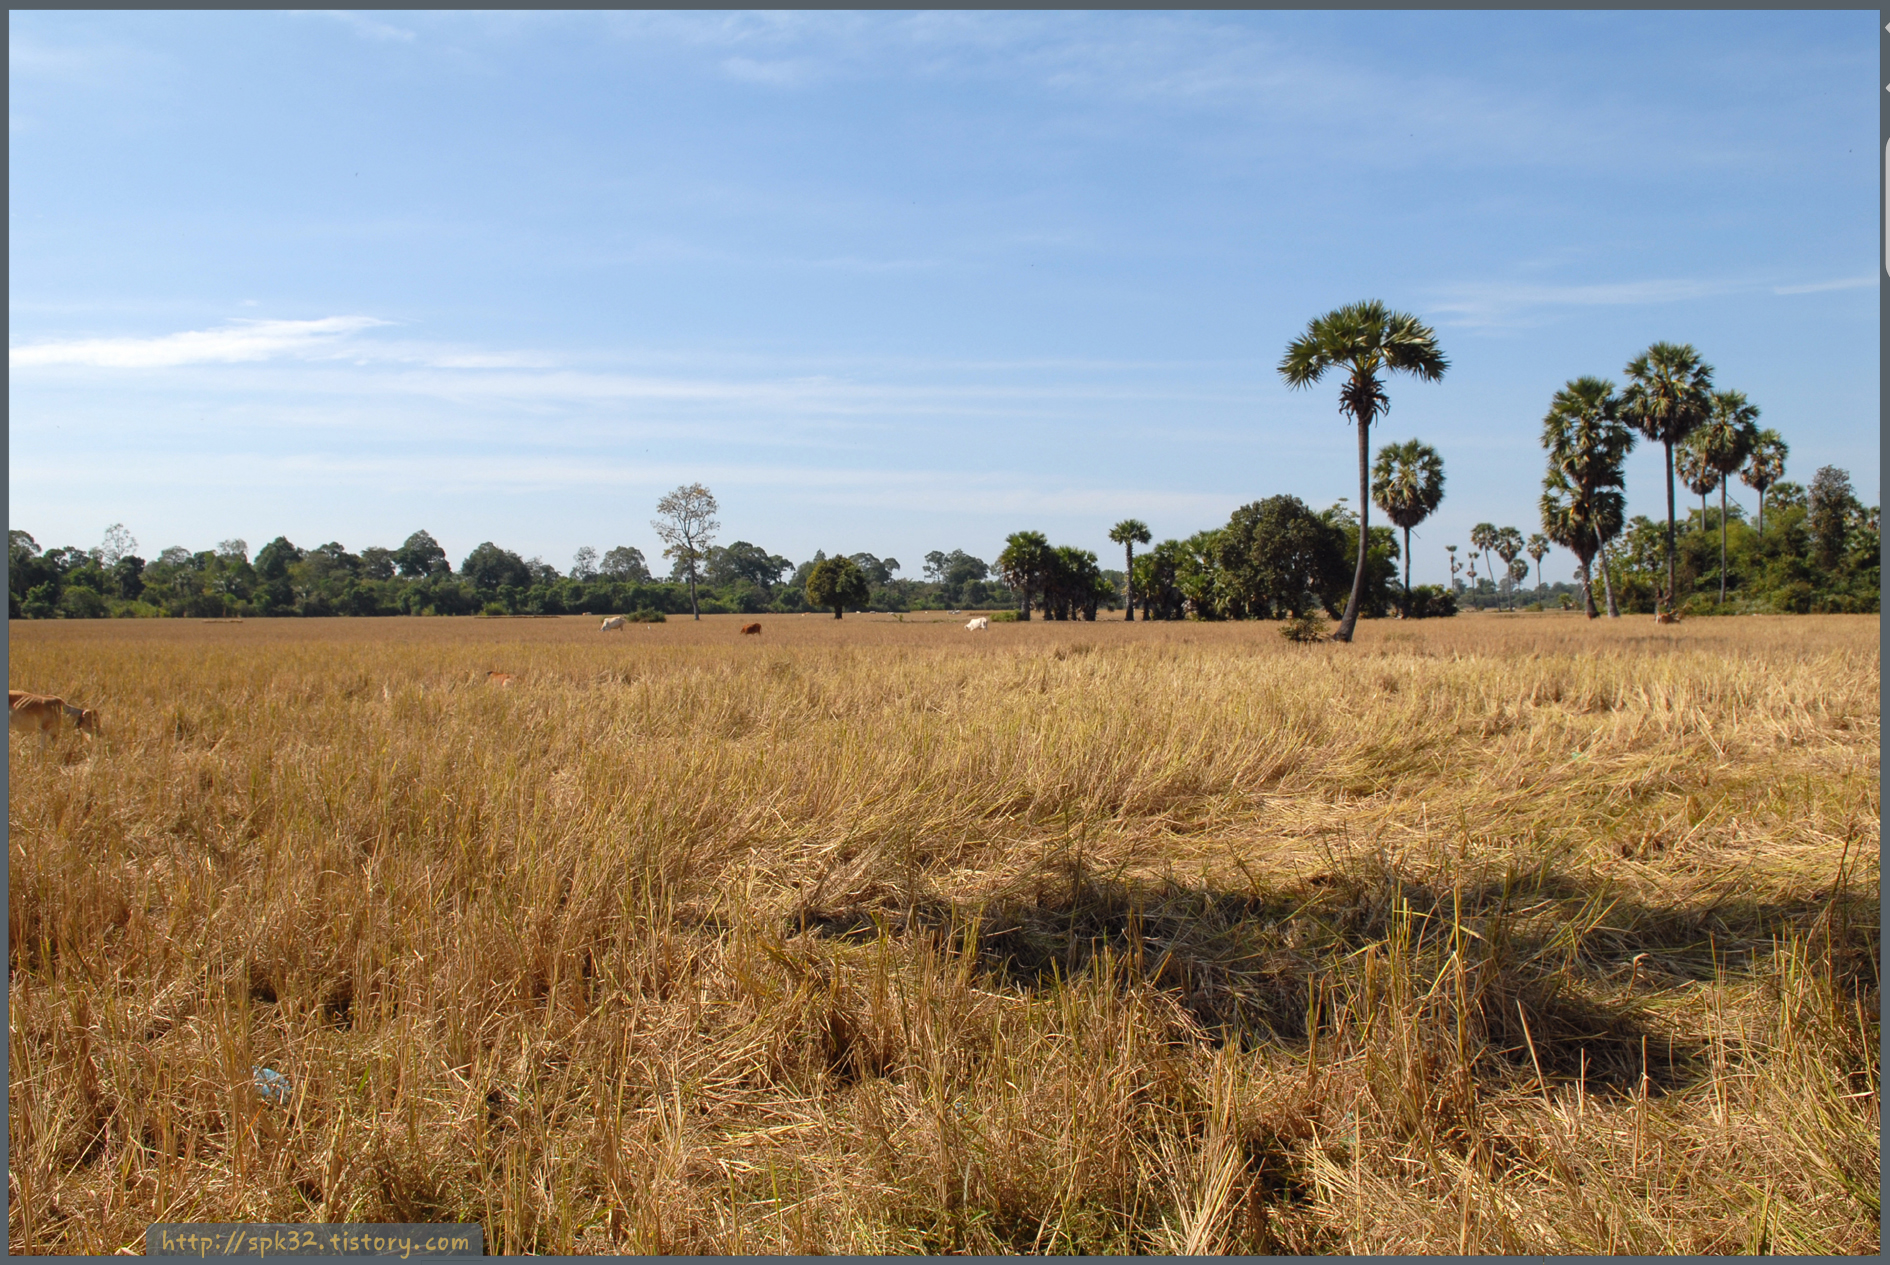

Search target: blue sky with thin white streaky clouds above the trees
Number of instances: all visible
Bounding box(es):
[8,11,1882,582]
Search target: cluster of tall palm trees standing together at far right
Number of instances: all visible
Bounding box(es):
[1542,342,1788,618]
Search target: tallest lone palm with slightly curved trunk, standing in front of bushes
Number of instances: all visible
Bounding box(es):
[1280,299,1450,641]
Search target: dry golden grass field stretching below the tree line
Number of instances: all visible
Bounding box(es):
[8,615,1881,1254]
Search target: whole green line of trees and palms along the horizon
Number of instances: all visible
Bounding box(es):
[8,301,1881,627]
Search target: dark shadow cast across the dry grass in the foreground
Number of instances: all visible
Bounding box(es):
[786,847,1879,1093]
